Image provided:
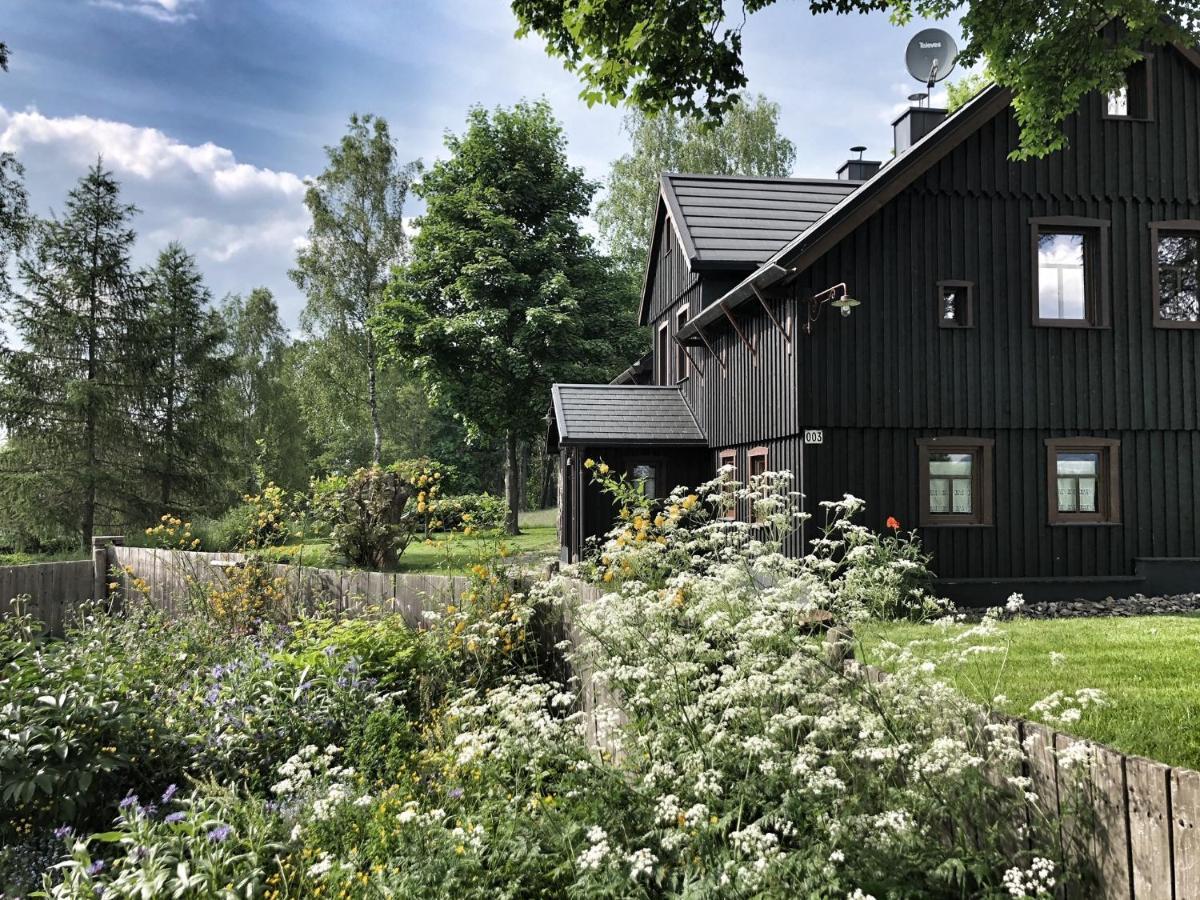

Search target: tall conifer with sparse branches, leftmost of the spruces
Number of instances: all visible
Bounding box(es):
[0,162,145,548]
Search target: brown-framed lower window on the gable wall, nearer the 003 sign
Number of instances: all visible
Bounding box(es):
[917,437,995,527]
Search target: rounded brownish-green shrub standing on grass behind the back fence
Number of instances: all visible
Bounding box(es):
[313,466,442,569]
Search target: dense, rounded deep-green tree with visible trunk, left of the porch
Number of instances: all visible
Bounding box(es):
[376,101,637,533]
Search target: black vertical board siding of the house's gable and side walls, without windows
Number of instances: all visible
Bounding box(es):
[652,48,1200,577]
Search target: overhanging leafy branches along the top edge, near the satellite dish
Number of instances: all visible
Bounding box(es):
[512,0,1200,158]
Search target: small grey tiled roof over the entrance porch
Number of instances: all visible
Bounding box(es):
[550,384,708,451]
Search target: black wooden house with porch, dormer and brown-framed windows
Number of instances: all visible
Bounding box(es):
[551,46,1200,601]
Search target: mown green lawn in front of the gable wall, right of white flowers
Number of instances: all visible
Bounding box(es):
[860,614,1200,769]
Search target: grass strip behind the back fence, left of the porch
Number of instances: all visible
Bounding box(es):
[258,509,558,575]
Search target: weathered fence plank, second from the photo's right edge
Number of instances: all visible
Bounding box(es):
[1124,756,1172,900]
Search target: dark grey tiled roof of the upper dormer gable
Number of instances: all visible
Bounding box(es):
[660,173,862,269]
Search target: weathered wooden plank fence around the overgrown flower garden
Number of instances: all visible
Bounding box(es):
[0,546,1200,900]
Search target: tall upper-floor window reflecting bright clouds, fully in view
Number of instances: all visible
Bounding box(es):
[1030,216,1109,328]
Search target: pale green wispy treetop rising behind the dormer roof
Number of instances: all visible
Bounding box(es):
[596,95,796,277]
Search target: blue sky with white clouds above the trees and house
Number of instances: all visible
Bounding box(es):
[0,0,958,325]
